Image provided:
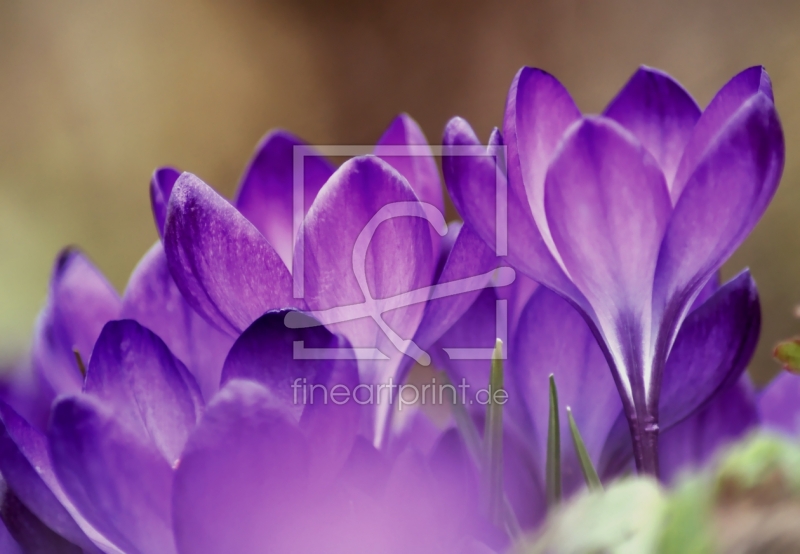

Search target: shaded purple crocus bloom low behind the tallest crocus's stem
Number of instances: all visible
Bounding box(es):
[432,271,760,527]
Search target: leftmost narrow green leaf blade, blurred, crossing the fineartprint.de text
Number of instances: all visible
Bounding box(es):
[483,339,503,522]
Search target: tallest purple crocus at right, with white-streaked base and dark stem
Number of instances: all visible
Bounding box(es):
[444,63,784,473]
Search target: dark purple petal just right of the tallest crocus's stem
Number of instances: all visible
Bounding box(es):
[659,270,761,429]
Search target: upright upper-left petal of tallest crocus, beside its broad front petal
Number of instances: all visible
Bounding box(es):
[503,67,581,266]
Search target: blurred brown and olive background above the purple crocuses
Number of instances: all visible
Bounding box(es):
[0,0,800,382]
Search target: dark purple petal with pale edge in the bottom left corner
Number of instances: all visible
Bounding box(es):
[0,403,103,552]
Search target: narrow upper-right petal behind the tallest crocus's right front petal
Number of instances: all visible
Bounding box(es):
[671,66,775,203]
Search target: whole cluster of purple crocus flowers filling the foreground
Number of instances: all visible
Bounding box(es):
[0,62,788,554]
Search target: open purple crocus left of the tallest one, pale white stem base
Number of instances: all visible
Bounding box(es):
[159,116,495,443]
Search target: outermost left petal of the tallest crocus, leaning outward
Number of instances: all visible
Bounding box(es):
[442,118,580,304]
